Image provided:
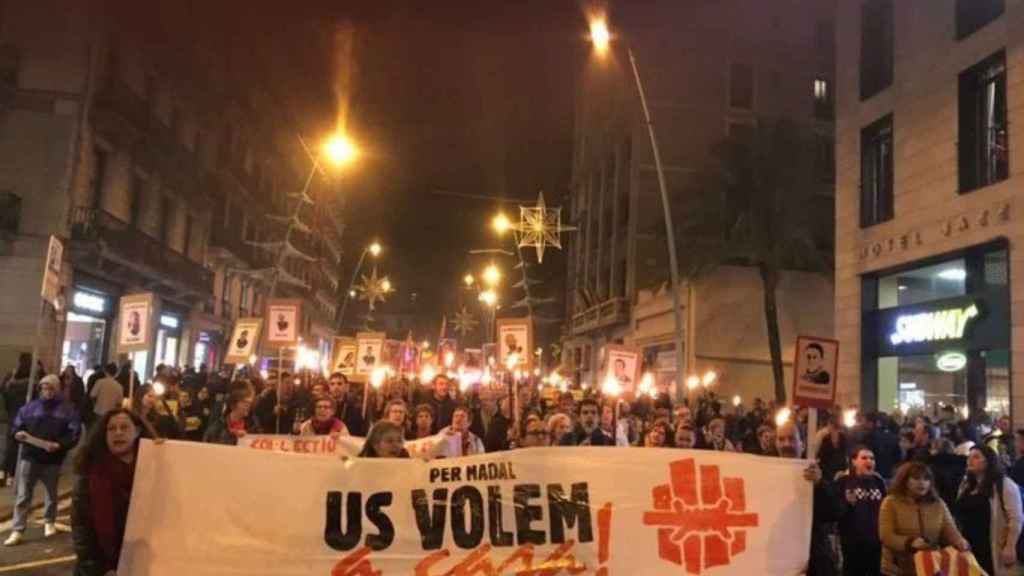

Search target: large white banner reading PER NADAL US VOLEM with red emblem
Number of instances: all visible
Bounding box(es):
[118,441,812,576]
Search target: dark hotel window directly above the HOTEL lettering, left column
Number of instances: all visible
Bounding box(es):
[860,115,893,228]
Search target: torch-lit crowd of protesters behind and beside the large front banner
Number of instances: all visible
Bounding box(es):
[3,359,1024,576]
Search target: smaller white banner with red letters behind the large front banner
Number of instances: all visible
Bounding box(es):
[239,434,462,458]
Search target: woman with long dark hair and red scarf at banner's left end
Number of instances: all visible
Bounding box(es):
[71,408,142,576]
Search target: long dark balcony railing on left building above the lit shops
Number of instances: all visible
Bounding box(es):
[71,207,213,296]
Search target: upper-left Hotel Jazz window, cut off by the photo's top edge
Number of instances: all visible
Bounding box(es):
[860,0,895,99]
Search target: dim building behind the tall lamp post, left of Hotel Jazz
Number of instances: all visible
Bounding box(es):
[563,0,835,398]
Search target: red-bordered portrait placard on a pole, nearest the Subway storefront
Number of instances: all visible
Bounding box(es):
[793,336,839,408]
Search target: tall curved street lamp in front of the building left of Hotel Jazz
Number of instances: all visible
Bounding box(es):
[590,19,686,402]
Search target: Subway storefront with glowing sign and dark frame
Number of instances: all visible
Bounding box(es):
[861,240,1011,420]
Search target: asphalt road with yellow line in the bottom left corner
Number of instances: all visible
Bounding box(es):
[0,490,75,576]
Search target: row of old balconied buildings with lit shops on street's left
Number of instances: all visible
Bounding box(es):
[0,0,340,377]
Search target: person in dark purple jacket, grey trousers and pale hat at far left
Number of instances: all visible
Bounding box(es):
[4,376,80,546]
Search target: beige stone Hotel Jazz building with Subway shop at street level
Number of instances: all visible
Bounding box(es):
[836,0,1024,424]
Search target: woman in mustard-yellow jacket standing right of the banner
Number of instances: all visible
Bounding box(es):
[879,462,970,576]
